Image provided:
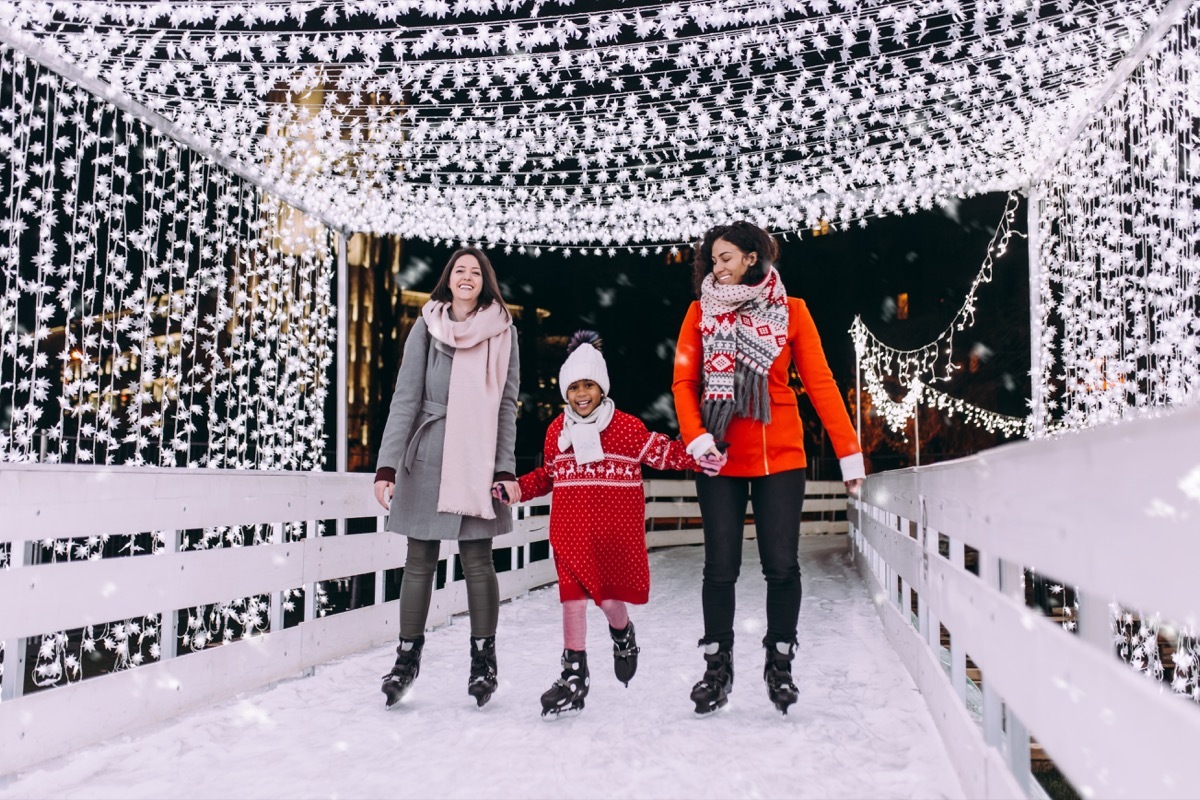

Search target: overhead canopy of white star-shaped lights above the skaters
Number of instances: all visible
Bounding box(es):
[0,0,1162,248]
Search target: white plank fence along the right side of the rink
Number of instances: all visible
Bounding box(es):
[851,409,1200,798]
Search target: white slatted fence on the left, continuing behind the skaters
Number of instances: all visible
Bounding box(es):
[0,464,847,775]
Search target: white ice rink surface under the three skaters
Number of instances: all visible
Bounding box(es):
[0,536,962,799]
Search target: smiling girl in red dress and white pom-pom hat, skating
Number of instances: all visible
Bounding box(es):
[494,331,721,720]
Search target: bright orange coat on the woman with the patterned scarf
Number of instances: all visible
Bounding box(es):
[671,297,862,477]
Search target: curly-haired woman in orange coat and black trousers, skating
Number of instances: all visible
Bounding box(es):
[673,222,865,715]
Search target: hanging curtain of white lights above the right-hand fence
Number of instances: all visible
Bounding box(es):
[1033,4,1200,428]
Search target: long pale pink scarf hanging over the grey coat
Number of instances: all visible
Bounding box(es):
[421,300,512,519]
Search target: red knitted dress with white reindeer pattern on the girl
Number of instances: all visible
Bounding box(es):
[517,410,696,603]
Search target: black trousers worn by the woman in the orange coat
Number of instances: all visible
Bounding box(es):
[696,469,804,646]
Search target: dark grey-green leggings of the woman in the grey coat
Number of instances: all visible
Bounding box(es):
[400,536,500,639]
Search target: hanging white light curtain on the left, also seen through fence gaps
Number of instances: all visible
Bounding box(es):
[0,52,334,686]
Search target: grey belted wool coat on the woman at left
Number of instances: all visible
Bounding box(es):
[378,319,521,540]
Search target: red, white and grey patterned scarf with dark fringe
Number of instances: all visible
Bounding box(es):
[700,266,787,439]
